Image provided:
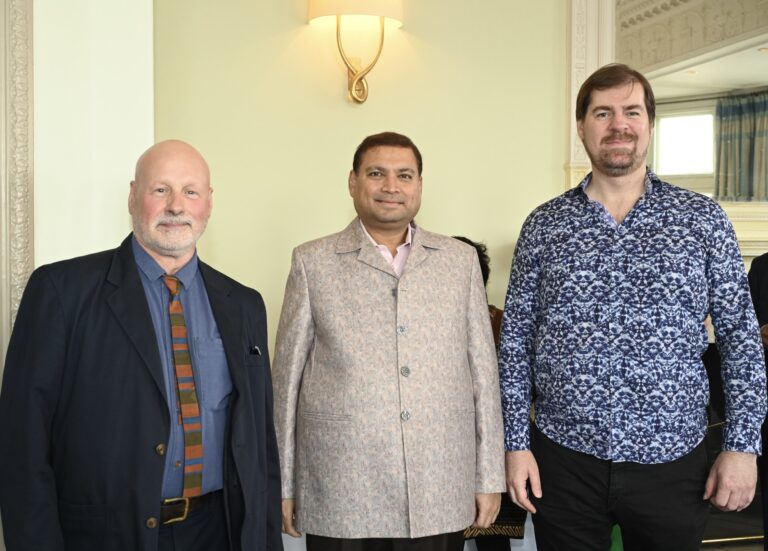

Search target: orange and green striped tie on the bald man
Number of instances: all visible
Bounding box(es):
[165,275,203,497]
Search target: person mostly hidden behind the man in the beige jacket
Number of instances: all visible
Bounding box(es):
[453,235,528,551]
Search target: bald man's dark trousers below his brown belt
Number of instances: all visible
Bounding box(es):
[157,492,229,551]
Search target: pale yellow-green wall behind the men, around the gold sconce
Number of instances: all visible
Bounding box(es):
[155,0,570,348]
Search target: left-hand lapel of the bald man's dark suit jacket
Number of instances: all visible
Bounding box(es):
[107,235,168,402]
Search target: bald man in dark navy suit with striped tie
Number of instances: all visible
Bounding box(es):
[0,141,282,551]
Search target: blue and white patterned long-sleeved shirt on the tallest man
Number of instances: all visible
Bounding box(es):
[499,170,766,464]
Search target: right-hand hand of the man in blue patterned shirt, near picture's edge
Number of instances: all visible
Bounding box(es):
[704,451,757,511]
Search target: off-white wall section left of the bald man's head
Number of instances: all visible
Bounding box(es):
[33,0,154,266]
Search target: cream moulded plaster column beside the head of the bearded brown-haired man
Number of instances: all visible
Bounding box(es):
[566,0,616,189]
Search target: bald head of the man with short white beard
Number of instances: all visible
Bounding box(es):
[128,140,213,273]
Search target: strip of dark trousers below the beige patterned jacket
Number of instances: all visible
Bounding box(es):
[307,530,464,551]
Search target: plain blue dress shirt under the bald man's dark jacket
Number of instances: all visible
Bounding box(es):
[133,237,232,499]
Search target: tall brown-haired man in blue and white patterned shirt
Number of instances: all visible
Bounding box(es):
[500,64,766,551]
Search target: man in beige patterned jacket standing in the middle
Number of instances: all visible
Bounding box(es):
[274,132,505,551]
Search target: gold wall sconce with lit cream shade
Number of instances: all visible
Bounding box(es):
[309,0,403,103]
